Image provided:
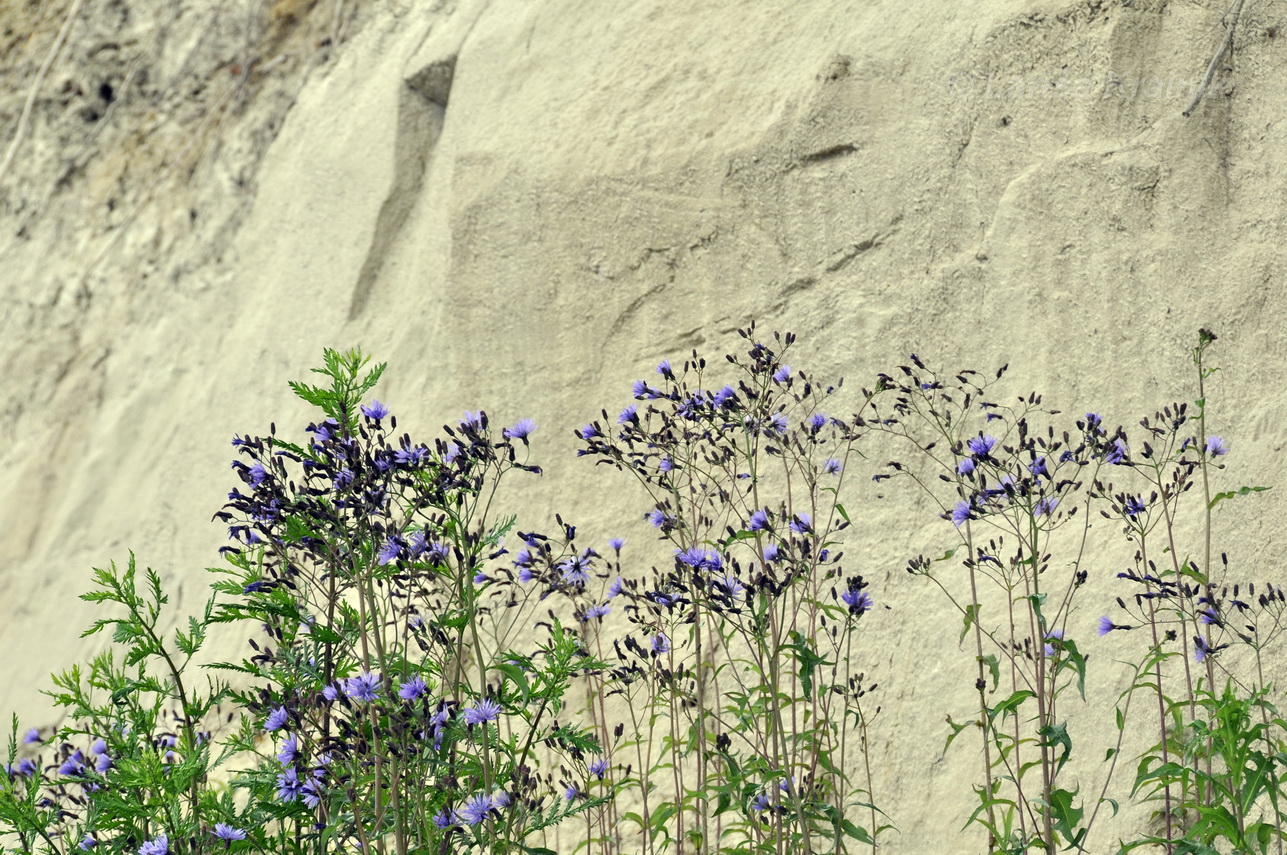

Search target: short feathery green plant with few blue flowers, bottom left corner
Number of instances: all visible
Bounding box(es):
[0,555,231,855]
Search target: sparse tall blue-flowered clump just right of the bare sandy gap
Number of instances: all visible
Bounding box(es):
[870,355,1096,852]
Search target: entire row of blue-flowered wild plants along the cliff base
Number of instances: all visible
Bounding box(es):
[0,326,1287,855]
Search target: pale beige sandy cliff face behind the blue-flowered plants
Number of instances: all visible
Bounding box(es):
[0,0,1287,852]
